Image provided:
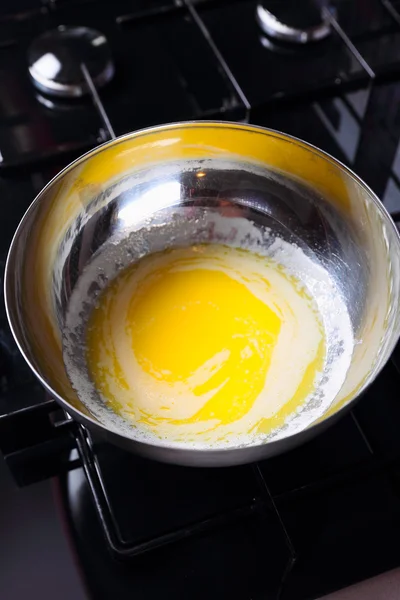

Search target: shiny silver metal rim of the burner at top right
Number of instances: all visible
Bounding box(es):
[256,3,331,44]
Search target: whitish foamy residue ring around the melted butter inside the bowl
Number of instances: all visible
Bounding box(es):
[64,208,353,449]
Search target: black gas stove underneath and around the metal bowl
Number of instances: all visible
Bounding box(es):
[0,0,400,600]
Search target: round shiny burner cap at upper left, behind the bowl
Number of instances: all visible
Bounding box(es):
[28,25,114,98]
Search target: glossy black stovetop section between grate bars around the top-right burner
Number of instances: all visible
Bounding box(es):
[199,2,368,108]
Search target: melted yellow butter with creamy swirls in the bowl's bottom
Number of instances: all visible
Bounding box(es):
[87,245,325,445]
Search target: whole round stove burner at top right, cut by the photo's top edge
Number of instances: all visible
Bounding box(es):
[256,0,330,44]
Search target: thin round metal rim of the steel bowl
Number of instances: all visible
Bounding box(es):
[3,120,400,454]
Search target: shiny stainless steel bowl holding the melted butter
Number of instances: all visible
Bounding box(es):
[5,122,400,466]
